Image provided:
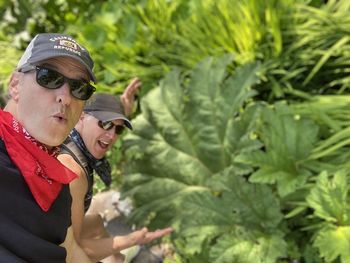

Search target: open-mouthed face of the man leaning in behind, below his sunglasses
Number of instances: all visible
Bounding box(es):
[78,114,124,159]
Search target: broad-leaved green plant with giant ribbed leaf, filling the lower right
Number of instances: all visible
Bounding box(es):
[124,57,350,263]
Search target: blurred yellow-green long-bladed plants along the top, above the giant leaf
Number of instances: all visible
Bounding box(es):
[65,0,349,102]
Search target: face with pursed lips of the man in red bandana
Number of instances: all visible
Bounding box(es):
[12,57,89,146]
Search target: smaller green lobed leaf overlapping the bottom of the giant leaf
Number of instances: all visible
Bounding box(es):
[180,169,284,262]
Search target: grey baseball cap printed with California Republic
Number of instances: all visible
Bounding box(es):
[17,33,96,83]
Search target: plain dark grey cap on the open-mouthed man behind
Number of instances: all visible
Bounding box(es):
[84,93,132,130]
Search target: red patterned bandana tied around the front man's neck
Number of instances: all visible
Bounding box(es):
[0,109,77,212]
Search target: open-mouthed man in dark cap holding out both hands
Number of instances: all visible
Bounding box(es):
[59,89,172,262]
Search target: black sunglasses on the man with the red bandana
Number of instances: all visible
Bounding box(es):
[19,66,96,100]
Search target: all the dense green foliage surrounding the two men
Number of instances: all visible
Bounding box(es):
[0,0,350,263]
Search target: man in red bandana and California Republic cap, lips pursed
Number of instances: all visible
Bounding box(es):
[0,34,96,263]
